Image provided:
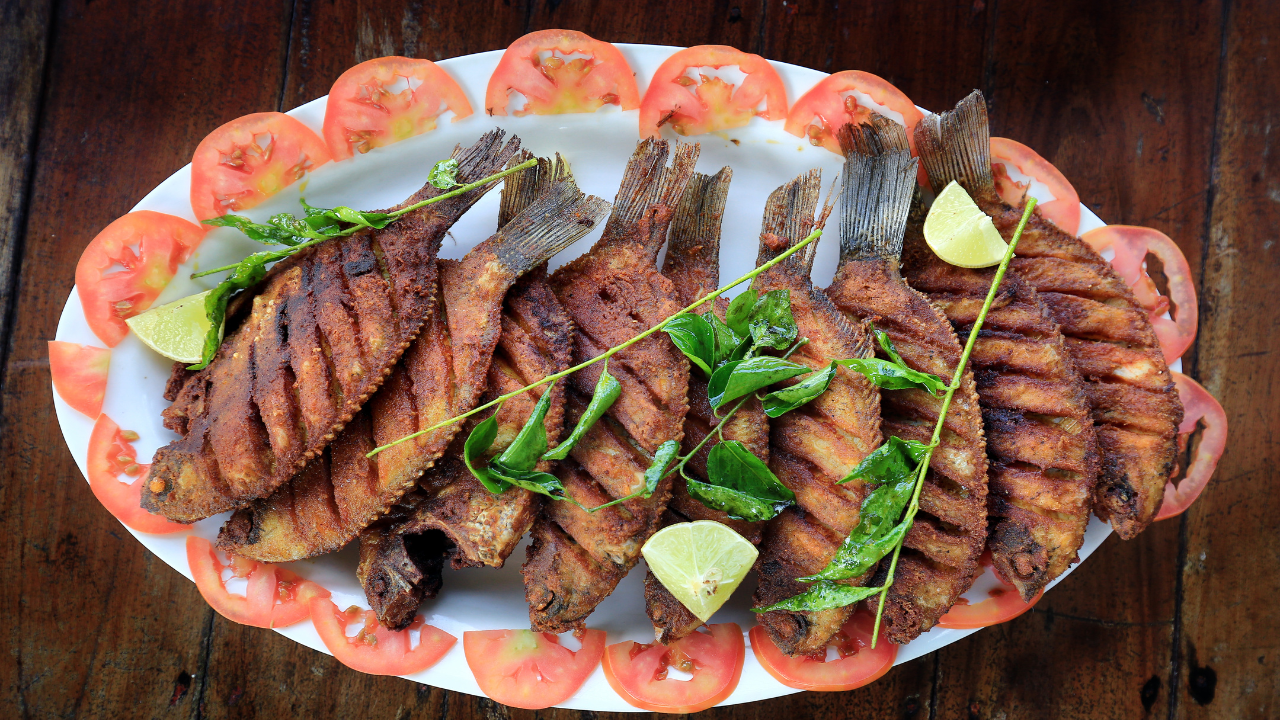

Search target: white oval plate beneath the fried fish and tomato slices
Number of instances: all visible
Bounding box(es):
[54,45,1111,711]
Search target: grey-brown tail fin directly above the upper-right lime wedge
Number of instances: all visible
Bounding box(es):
[915,90,996,196]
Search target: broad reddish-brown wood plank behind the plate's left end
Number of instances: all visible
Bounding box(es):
[0,0,291,717]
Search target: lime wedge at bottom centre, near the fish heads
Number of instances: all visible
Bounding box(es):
[640,520,758,623]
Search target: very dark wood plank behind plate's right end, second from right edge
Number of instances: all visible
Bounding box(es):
[936,1,1221,717]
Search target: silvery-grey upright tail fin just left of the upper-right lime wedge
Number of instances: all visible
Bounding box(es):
[840,143,916,266]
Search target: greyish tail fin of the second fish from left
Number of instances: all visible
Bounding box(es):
[486,170,609,277]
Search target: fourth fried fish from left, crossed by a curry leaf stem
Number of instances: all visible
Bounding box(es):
[522,140,698,633]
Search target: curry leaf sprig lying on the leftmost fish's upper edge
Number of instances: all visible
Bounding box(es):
[188,158,538,370]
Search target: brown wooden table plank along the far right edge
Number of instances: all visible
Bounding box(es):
[1171,1,1280,717]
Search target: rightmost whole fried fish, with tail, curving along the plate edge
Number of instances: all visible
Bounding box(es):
[916,91,1183,539]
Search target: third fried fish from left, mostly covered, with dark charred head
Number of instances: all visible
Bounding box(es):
[357,154,573,628]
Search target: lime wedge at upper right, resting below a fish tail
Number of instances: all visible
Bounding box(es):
[924,181,1009,268]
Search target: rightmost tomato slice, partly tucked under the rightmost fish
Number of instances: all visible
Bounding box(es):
[1156,373,1226,520]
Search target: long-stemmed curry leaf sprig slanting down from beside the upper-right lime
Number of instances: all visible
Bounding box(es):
[755,197,1036,648]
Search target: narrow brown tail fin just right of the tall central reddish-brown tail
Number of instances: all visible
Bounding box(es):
[662,165,733,292]
